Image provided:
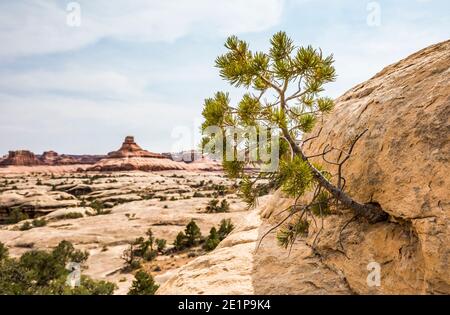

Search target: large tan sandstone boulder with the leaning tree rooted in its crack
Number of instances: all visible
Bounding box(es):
[159,41,450,294]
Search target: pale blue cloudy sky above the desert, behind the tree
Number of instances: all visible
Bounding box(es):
[0,0,450,155]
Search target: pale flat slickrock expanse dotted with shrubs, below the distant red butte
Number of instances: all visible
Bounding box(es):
[0,171,247,294]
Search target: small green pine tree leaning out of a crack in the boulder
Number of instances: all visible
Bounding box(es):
[202,32,386,251]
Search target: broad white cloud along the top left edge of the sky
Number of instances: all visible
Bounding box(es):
[0,0,283,57]
